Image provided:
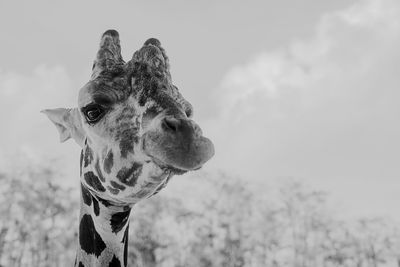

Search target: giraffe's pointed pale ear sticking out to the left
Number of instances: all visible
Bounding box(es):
[41,108,85,147]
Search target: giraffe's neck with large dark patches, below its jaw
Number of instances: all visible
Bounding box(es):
[75,185,131,267]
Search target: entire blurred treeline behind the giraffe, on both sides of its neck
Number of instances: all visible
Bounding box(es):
[0,167,400,267]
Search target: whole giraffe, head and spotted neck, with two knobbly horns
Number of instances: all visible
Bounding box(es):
[42,30,214,267]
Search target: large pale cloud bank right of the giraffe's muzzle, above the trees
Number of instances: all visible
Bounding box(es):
[207,0,400,216]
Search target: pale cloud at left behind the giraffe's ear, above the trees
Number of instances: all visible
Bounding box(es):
[0,65,79,181]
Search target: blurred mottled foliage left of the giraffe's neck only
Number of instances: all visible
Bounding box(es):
[0,167,79,266]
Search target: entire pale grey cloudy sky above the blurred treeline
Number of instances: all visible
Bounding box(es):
[0,0,400,219]
